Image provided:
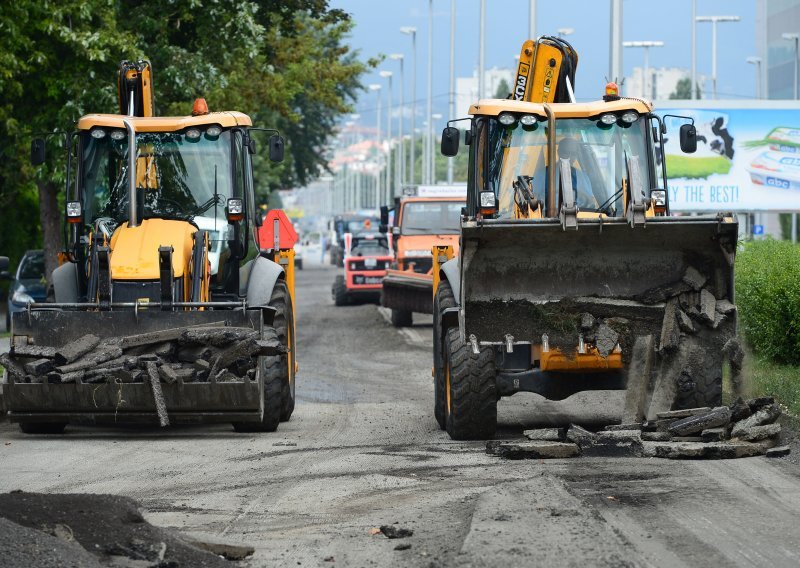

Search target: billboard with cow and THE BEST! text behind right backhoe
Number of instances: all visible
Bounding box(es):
[656,101,800,211]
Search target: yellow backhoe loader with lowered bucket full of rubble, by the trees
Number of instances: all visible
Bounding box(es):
[0,61,295,433]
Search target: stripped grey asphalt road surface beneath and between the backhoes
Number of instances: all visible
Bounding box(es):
[0,262,800,568]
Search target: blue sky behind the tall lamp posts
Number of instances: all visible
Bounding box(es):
[330,0,757,128]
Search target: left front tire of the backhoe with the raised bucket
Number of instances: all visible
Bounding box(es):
[444,328,497,440]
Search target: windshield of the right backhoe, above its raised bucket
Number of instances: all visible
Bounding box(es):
[478,113,650,218]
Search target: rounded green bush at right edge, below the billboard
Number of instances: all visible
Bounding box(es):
[736,239,800,365]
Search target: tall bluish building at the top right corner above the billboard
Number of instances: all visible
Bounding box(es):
[756,0,800,99]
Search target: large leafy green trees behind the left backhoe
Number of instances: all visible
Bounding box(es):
[0,0,373,266]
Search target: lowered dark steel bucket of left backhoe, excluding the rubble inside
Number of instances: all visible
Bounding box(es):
[4,309,264,424]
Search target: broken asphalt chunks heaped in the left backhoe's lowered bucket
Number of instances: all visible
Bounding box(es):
[0,326,283,384]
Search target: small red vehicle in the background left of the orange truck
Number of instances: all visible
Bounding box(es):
[332,233,393,306]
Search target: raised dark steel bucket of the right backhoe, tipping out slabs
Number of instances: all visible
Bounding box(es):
[461,217,737,353]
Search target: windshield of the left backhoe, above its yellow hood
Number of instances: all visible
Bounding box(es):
[81,129,233,223]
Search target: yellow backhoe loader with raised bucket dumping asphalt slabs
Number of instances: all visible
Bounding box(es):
[433,37,737,439]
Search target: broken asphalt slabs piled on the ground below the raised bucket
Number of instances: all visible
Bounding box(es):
[486,397,789,459]
